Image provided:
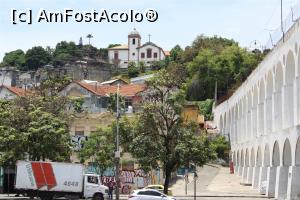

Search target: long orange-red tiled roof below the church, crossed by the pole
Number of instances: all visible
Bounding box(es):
[76,82,146,97]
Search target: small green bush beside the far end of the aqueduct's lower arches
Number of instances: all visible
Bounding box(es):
[211,135,230,162]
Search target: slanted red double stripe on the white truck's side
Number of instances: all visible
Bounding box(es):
[31,162,57,190]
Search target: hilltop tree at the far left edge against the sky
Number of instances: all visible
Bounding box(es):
[3,49,25,70]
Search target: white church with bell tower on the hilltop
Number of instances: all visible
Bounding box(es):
[108,29,169,69]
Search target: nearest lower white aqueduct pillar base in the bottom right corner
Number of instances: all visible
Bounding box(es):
[287,166,300,200]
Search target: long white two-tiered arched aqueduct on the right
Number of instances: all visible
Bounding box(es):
[214,21,300,199]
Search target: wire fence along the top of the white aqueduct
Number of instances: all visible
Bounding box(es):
[264,1,300,49]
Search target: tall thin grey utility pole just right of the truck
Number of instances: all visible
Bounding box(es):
[115,83,120,200]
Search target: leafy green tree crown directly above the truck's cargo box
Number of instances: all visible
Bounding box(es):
[25,108,71,161]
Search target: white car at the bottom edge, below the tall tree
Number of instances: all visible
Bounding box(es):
[128,189,176,200]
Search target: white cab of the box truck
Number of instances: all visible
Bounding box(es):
[83,174,108,200]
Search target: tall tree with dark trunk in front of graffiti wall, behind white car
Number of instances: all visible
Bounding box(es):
[130,68,213,194]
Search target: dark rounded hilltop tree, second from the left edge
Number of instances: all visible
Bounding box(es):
[25,46,51,70]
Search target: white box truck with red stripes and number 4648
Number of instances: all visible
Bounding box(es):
[15,161,108,200]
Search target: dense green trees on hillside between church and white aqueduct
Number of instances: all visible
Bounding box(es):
[169,35,268,101]
